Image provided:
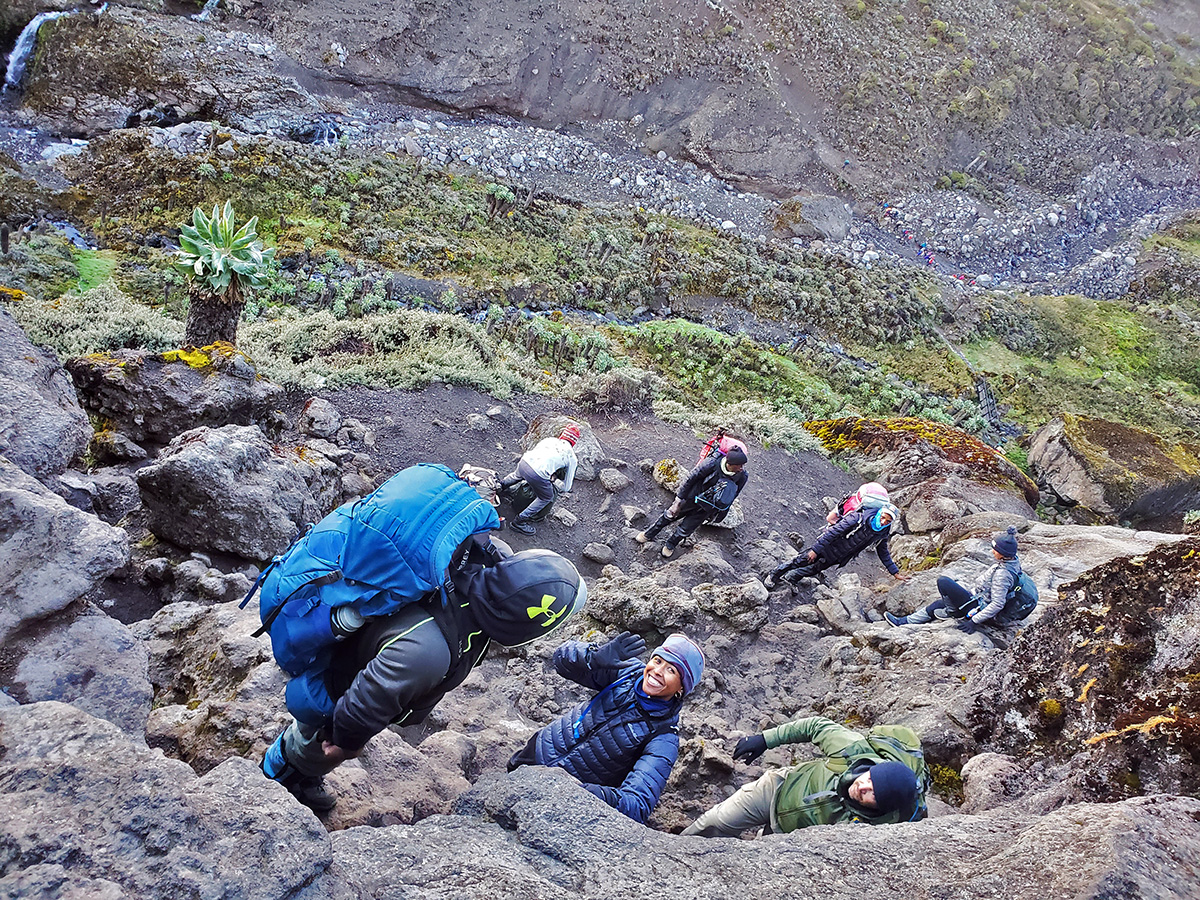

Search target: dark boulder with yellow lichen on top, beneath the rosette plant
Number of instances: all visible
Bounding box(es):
[67,344,283,444]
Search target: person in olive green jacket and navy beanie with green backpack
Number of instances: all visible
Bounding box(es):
[683,715,924,838]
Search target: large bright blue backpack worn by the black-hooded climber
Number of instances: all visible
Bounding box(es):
[241,463,500,725]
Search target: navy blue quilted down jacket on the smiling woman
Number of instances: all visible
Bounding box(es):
[534,641,683,823]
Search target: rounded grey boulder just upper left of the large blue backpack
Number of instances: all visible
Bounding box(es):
[137,425,353,560]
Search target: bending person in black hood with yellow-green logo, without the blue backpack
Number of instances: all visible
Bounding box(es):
[262,541,587,812]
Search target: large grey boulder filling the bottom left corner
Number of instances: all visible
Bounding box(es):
[0,702,344,900]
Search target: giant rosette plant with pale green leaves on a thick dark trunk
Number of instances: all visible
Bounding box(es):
[175,200,275,347]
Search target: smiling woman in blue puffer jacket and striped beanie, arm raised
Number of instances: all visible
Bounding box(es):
[509,631,704,823]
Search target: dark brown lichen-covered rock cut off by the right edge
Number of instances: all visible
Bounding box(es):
[972,538,1200,800]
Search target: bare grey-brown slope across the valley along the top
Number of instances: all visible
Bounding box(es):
[9,0,1200,200]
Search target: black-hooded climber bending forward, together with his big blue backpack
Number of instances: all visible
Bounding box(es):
[250,463,587,812]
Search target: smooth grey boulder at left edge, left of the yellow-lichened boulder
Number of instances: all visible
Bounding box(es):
[0,310,91,484]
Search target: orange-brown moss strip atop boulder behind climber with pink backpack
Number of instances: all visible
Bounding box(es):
[804,418,1038,506]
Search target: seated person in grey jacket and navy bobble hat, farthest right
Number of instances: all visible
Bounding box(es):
[883,526,1038,635]
